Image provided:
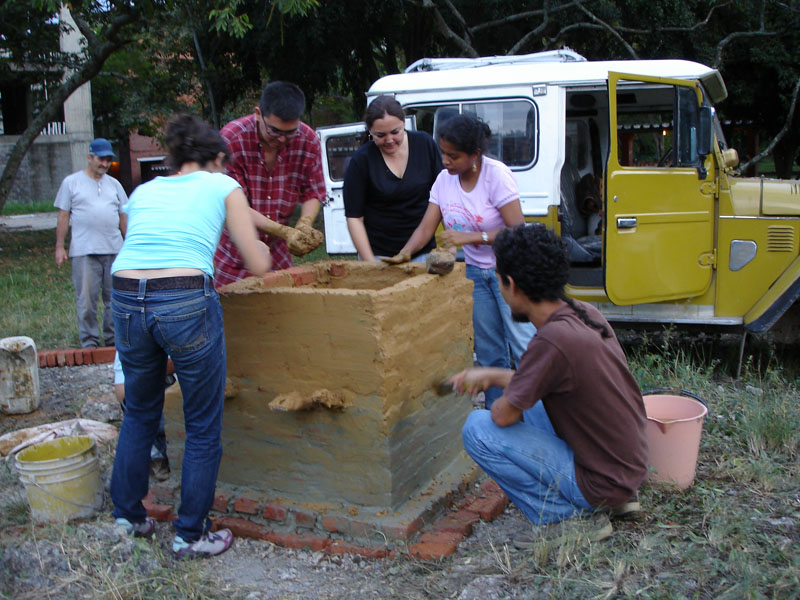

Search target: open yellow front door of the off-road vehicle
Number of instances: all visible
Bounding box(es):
[603,73,715,305]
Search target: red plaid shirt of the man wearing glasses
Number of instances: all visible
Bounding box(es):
[214,114,325,287]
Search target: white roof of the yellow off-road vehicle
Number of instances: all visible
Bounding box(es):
[367,60,727,102]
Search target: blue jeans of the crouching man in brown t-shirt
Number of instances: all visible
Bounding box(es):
[461,402,592,525]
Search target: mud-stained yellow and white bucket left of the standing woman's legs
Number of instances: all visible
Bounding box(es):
[17,436,103,521]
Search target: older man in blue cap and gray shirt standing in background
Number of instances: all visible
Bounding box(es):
[54,138,128,348]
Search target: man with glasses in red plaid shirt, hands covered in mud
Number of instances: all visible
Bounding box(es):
[214,81,325,287]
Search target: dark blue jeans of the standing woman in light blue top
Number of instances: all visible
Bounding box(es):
[111,276,225,541]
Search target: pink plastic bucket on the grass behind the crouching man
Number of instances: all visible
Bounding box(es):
[644,394,708,489]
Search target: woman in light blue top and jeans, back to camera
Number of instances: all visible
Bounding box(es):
[111,115,272,557]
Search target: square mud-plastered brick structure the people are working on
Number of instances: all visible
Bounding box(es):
[166,262,472,507]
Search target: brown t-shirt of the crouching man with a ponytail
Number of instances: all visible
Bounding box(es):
[504,302,647,507]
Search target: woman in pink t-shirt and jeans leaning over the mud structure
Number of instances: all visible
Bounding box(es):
[390,114,536,408]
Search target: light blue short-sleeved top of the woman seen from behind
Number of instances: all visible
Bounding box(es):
[111,171,240,277]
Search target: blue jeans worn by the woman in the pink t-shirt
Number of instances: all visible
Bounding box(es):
[467,265,536,408]
